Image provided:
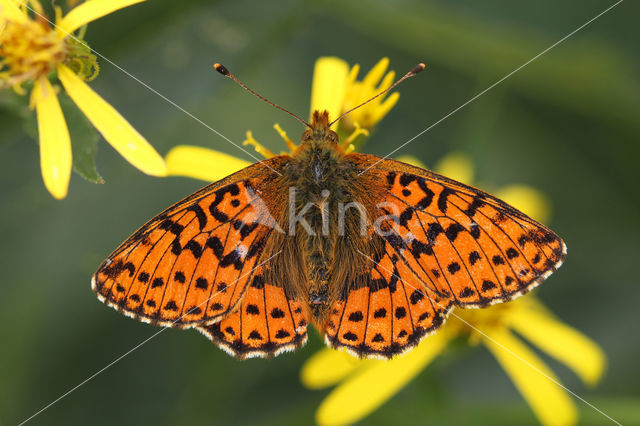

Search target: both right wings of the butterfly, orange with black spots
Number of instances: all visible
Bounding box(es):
[325,154,566,357]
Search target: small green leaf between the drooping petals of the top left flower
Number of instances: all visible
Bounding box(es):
[60,95,104,183]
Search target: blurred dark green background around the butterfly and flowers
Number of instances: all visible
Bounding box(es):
[0,0,640,425]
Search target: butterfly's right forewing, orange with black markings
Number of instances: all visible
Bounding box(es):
[380,156,566,306]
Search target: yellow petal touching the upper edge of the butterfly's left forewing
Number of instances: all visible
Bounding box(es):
[166,145,251,182]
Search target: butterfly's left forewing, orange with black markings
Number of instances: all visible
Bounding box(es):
[92,157,286,327]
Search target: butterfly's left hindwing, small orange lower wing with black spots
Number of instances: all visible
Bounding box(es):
[198,269,309,359]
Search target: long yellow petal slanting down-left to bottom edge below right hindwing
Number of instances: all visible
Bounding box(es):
[316,330,450,425]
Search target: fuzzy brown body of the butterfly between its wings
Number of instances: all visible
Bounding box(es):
[265,112,374,328]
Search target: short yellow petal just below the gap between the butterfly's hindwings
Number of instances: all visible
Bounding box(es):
[300,348,375,389]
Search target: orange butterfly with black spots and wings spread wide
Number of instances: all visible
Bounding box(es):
[92,64,566,359]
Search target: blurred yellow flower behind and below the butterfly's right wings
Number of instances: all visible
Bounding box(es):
[301,153,606,425]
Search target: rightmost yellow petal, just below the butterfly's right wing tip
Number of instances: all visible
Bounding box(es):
[505,304,606,386]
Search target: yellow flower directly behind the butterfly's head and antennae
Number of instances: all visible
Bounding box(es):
[165,57,400,181]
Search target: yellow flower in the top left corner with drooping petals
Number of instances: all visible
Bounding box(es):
[0,0,167,199]
